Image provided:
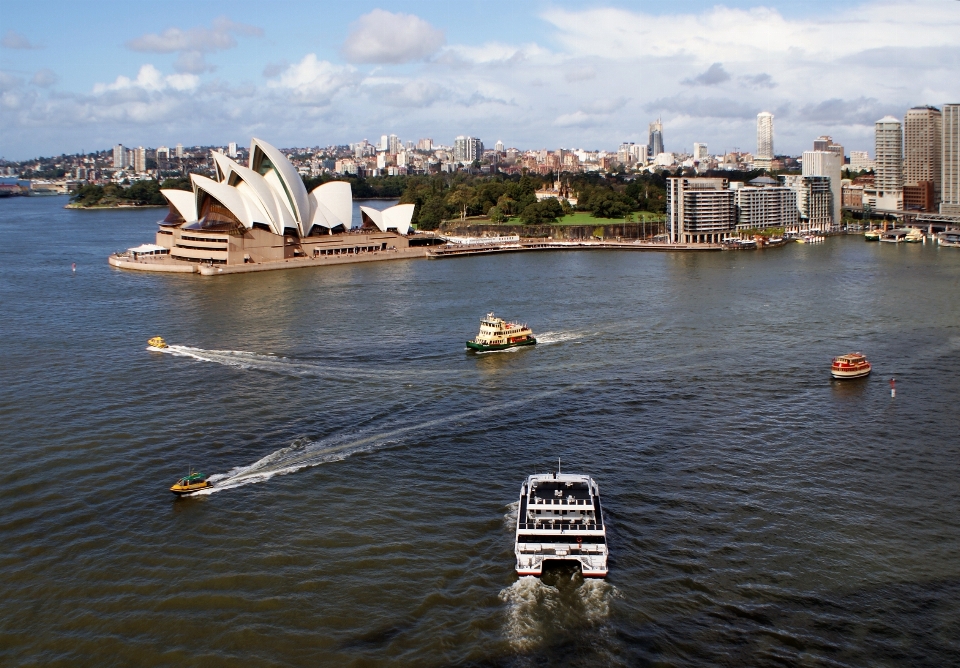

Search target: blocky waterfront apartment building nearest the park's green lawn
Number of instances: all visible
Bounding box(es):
[667,178,737,244]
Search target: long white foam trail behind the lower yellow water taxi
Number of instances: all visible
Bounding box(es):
[186,390,565,496]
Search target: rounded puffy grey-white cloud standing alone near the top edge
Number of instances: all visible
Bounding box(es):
[341,9,446,64]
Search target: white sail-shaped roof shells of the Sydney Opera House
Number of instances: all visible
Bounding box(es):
[160,138,413,237]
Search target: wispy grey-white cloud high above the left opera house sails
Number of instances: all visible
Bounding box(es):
[126,16,263,74]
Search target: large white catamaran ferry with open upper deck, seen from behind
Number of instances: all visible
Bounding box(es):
[514,463,607,578]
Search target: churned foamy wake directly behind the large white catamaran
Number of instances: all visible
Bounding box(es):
[499,572,620,652]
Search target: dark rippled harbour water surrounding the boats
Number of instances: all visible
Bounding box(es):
[0,198,960,666]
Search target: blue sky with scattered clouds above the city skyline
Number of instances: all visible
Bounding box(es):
[0,0,960,160]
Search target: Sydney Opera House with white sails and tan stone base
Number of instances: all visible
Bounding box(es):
[110,139,423,274]
